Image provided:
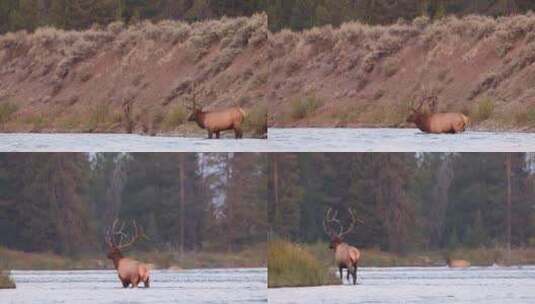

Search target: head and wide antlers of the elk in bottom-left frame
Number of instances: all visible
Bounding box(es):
[104,219,147,262]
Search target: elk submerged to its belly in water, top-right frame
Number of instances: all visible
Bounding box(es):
[407,96,469,134]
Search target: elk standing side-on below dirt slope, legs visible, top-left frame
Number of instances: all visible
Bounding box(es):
[188,88,246,139]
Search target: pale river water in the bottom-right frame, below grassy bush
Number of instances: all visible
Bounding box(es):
[268,266,535,304]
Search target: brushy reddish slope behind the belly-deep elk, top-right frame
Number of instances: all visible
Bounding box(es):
[266,13,535,130]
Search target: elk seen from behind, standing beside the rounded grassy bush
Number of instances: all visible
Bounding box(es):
[323,208,360,285]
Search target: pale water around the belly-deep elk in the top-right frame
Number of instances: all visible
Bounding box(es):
[268,128,535,152]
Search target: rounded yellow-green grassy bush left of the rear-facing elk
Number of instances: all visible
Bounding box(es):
[268,240,340,288]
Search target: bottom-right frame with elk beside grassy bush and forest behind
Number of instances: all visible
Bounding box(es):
[268,153,535,303]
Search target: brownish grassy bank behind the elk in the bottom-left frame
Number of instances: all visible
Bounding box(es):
[0,245,266,270]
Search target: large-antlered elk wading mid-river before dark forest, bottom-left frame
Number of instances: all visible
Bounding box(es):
[104,219,150,288]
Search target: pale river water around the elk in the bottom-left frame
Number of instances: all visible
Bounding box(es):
[0,269,267,304]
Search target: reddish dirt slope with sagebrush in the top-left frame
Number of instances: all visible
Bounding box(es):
[0,14,268,134]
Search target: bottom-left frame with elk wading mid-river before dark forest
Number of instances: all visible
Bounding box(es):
[0,153,268,303]
